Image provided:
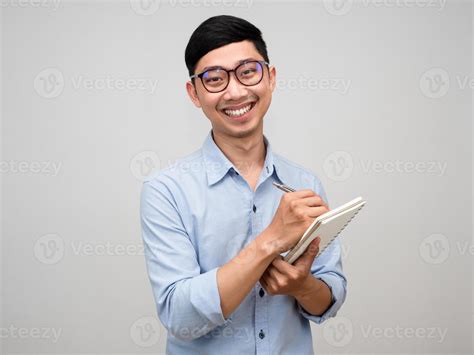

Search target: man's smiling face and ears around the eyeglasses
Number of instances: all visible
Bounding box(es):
[186,41,275,138]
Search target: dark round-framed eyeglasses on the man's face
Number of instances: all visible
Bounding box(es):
[189,60,270,93]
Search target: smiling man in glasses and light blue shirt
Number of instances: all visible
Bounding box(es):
[141,16,346,355]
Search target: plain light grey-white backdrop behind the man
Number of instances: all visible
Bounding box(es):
[0,0,474,354]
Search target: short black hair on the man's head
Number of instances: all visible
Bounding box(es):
[184,15,270,76]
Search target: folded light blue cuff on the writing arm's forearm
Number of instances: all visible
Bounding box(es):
[190,267,232,326]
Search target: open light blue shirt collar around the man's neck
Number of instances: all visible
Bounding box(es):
[202,130,284,186]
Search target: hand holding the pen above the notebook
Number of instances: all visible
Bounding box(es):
[268,190,329,255]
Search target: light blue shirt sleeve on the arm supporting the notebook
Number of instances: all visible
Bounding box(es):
[296,179,347,324]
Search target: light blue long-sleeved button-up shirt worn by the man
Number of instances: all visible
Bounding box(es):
[141,130,346,355]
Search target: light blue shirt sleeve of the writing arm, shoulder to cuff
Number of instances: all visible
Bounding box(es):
[140,178,230,341]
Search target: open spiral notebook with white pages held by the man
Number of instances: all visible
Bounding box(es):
[283,197,365,264]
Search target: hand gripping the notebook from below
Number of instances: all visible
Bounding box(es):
[260,237,321,297]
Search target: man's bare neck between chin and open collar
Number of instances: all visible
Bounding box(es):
[212,130,266,176]
